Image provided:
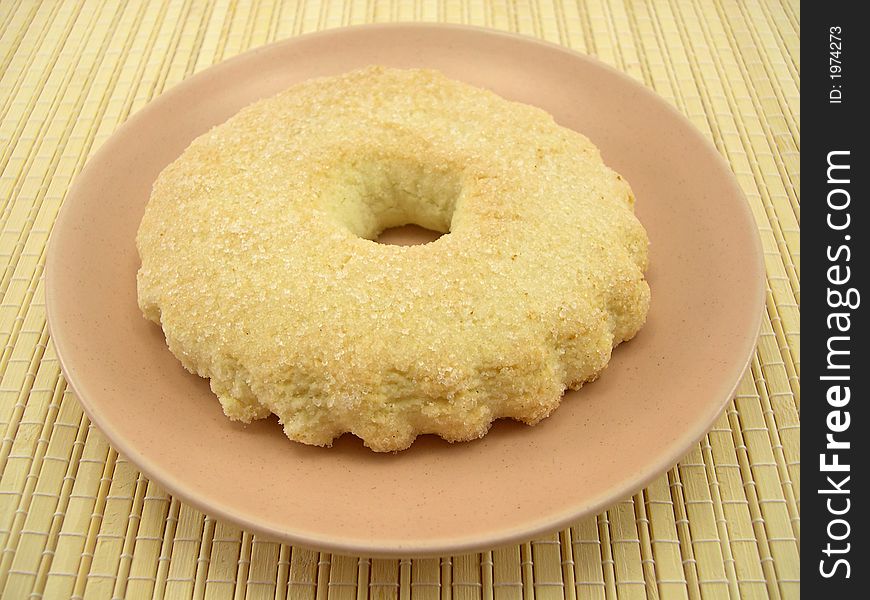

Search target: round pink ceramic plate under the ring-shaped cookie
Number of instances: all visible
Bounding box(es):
[46,25,764,556]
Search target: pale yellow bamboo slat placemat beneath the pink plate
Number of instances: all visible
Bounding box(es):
[0,0,800,600]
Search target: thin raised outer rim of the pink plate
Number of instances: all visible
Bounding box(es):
[44,22,766,557]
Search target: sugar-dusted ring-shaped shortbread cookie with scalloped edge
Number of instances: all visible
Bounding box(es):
[137,67,649,451]
